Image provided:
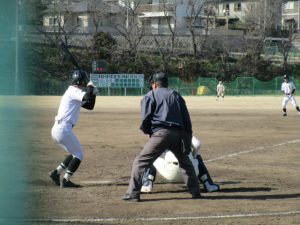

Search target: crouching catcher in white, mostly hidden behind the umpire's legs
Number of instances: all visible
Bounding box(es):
[141,136,220,193]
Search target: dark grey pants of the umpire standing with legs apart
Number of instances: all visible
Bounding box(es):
[126,129,200,195]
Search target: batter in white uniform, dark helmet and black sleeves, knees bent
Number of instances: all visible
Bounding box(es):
[49,70,98,188]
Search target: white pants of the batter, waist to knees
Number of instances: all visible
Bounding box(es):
[51,121,83,161]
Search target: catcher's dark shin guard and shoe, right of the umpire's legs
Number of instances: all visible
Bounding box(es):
[196,155,220,192]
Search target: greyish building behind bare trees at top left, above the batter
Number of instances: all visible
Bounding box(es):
[42,0,125,35]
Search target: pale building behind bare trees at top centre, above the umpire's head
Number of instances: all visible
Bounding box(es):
[138,0,215,35]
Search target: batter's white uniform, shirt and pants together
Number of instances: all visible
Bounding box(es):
[51,86,86,161]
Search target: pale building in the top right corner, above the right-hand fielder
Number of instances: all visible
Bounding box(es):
[282,0,300,32]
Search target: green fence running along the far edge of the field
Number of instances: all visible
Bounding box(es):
[25,77,300,96]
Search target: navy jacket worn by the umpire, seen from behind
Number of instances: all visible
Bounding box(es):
[140,87,192,135]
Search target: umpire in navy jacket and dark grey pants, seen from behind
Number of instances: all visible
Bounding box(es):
[122,72,201,202]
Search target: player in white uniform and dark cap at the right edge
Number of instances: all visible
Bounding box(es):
[281,75,300,116]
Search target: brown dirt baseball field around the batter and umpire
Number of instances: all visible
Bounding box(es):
[24,96,300,225]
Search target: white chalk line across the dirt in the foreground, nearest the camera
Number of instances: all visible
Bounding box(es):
[28,211,300,223]
